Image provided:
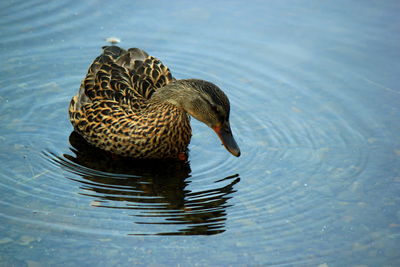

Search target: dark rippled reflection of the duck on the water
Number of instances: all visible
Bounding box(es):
[59,132,240,235]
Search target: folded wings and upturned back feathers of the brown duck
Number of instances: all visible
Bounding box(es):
[70,46,175,110]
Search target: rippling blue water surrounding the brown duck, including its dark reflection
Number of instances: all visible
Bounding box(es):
[0,1,400,266]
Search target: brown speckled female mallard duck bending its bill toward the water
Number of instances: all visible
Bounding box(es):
[69,46,240,159]
